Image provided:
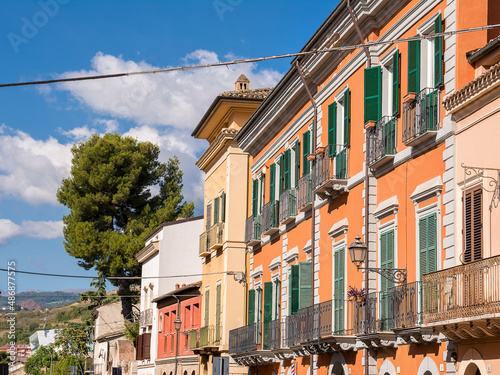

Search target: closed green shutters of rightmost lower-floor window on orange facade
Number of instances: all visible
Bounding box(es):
[418,214,437,276]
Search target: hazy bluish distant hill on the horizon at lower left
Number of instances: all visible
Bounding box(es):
[0,289,91,310]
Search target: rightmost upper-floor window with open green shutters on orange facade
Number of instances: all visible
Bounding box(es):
[408,14,443,93]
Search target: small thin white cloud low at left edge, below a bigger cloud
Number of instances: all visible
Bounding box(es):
[0,219,64,245]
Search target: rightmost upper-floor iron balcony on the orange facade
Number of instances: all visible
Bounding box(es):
[402,88,440,146]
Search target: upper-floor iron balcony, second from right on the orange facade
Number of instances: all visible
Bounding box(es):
[367,116,397,169]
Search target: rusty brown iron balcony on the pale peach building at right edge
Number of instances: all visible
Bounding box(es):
[423,256,500,341]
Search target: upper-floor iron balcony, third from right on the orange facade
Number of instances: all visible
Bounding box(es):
[313,145,348,199]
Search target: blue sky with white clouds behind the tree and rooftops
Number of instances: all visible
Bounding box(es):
[0,0,338,291]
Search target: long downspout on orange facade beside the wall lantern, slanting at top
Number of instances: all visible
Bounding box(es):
[347,0,372,375]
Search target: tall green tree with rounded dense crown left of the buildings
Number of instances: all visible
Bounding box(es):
[57,133,194,320]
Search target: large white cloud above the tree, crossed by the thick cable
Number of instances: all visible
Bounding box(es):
[57,50,281,130]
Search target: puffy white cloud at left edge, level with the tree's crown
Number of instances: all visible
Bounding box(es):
[0,125,71,205]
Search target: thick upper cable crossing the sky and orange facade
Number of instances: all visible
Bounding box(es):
[0,24,500,88]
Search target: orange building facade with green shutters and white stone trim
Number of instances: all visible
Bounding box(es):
[229,0,500,375]
